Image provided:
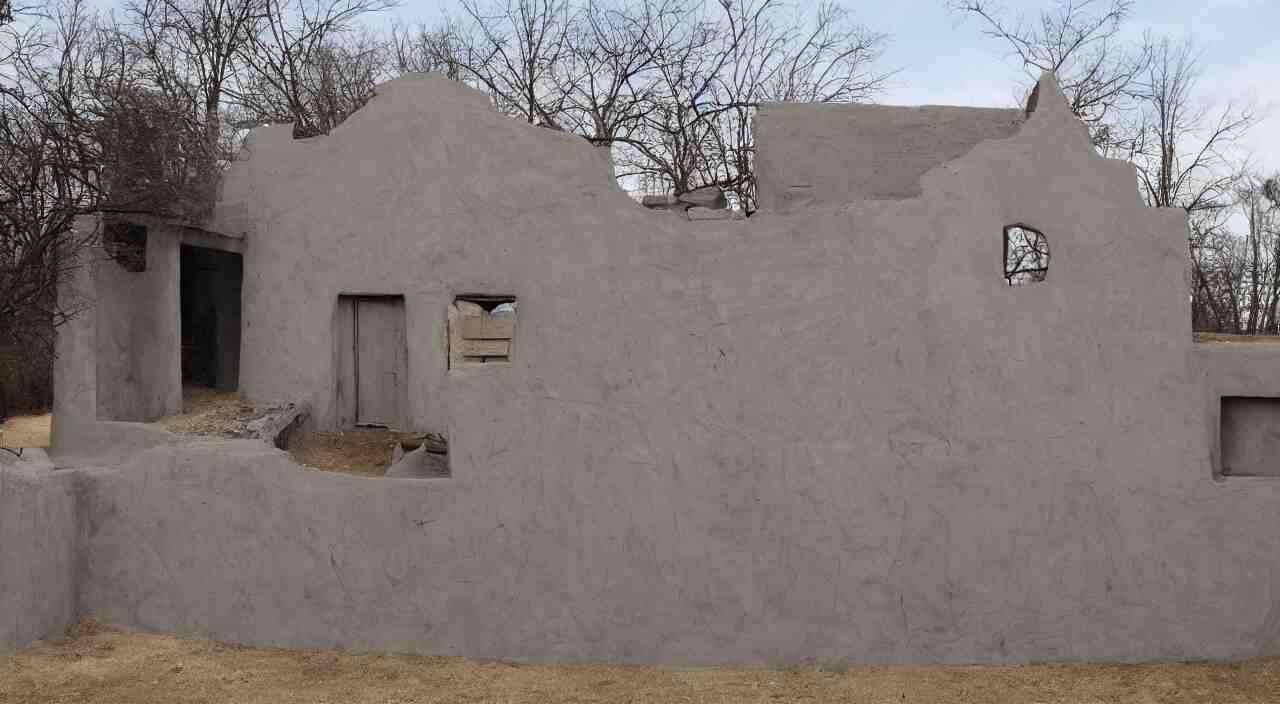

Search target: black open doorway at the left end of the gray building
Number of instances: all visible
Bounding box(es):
[180,244,244,390]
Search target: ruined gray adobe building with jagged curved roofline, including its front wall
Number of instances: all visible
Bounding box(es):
[0,76,1280,666]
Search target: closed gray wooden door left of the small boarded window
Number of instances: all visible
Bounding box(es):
[352,297,407,428]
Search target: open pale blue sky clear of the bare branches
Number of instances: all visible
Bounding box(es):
[397,0,1280,172]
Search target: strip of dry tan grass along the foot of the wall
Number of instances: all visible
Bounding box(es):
[0,621,1280,704]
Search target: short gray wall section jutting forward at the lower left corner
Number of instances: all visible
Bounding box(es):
[0,451,77,655]
